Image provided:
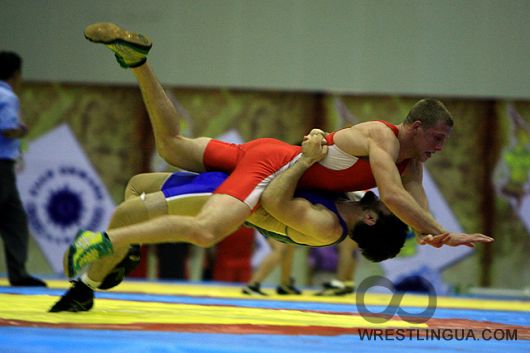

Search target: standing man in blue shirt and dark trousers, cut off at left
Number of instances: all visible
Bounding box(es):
[0,51,46,286]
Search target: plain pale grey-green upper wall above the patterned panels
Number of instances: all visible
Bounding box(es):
[0,0,530,99]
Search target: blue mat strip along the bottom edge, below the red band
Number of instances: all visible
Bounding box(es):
[0,327,530,353]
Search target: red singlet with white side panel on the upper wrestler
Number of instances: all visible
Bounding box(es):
[204,120,408,209]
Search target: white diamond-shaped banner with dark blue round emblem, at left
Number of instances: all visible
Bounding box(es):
[17,125,114,273]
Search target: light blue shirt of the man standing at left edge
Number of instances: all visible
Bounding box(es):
[0,81,20,160]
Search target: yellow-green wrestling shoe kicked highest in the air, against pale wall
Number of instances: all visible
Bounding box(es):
[84,23,153,68]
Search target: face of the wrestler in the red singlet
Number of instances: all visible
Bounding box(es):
[412,121,451,162]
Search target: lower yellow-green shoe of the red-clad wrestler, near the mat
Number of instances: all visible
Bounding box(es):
[63,230,112,278]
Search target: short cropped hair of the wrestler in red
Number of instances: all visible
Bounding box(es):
[404,99,453,129]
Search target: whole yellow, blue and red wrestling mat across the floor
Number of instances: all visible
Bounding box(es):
[0,278,530,353]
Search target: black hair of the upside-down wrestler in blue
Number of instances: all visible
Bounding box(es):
[351,212,409,262]
